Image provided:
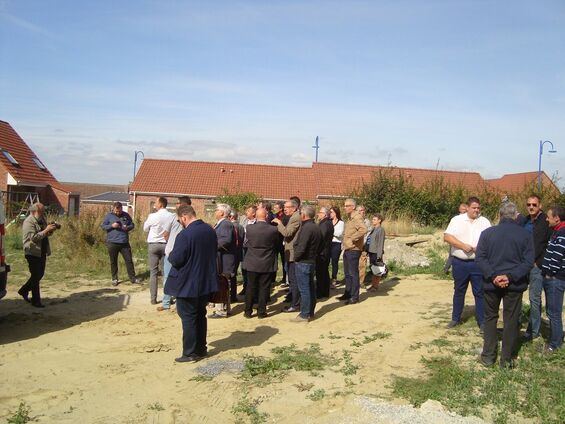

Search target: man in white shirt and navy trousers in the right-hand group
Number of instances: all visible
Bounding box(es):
[443,197,490,333]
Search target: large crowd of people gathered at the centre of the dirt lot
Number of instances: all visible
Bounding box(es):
[101,197,385,362]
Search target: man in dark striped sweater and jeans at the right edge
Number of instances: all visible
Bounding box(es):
[541,206,565,353]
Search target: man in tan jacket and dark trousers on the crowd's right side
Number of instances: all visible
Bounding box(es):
[338,199,367,305]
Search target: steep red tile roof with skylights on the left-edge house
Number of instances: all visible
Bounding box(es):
[0,121,70,192]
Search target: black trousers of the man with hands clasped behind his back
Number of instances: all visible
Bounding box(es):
[481,289,522,363]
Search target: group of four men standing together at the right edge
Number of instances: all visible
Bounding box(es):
[444,195,565,368]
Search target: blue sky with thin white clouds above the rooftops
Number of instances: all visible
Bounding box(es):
[0,0,565,186]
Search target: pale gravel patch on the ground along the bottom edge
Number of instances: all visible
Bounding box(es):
[355,396,486,424]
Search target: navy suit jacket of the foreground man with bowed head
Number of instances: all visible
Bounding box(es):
[165,219,218,297]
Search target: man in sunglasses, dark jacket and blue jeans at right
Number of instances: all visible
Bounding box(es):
[519,194,552,340]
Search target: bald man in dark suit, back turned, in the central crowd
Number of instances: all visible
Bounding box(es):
[243,208,279,318]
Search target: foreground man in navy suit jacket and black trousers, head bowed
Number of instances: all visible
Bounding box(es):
[165,205,218,362]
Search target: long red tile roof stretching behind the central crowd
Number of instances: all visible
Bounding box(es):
[130,159,494,200]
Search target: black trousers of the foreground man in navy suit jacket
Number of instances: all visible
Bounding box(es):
[177,295,210,356]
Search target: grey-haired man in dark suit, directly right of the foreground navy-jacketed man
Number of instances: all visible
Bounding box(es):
[210,203,237,318]
